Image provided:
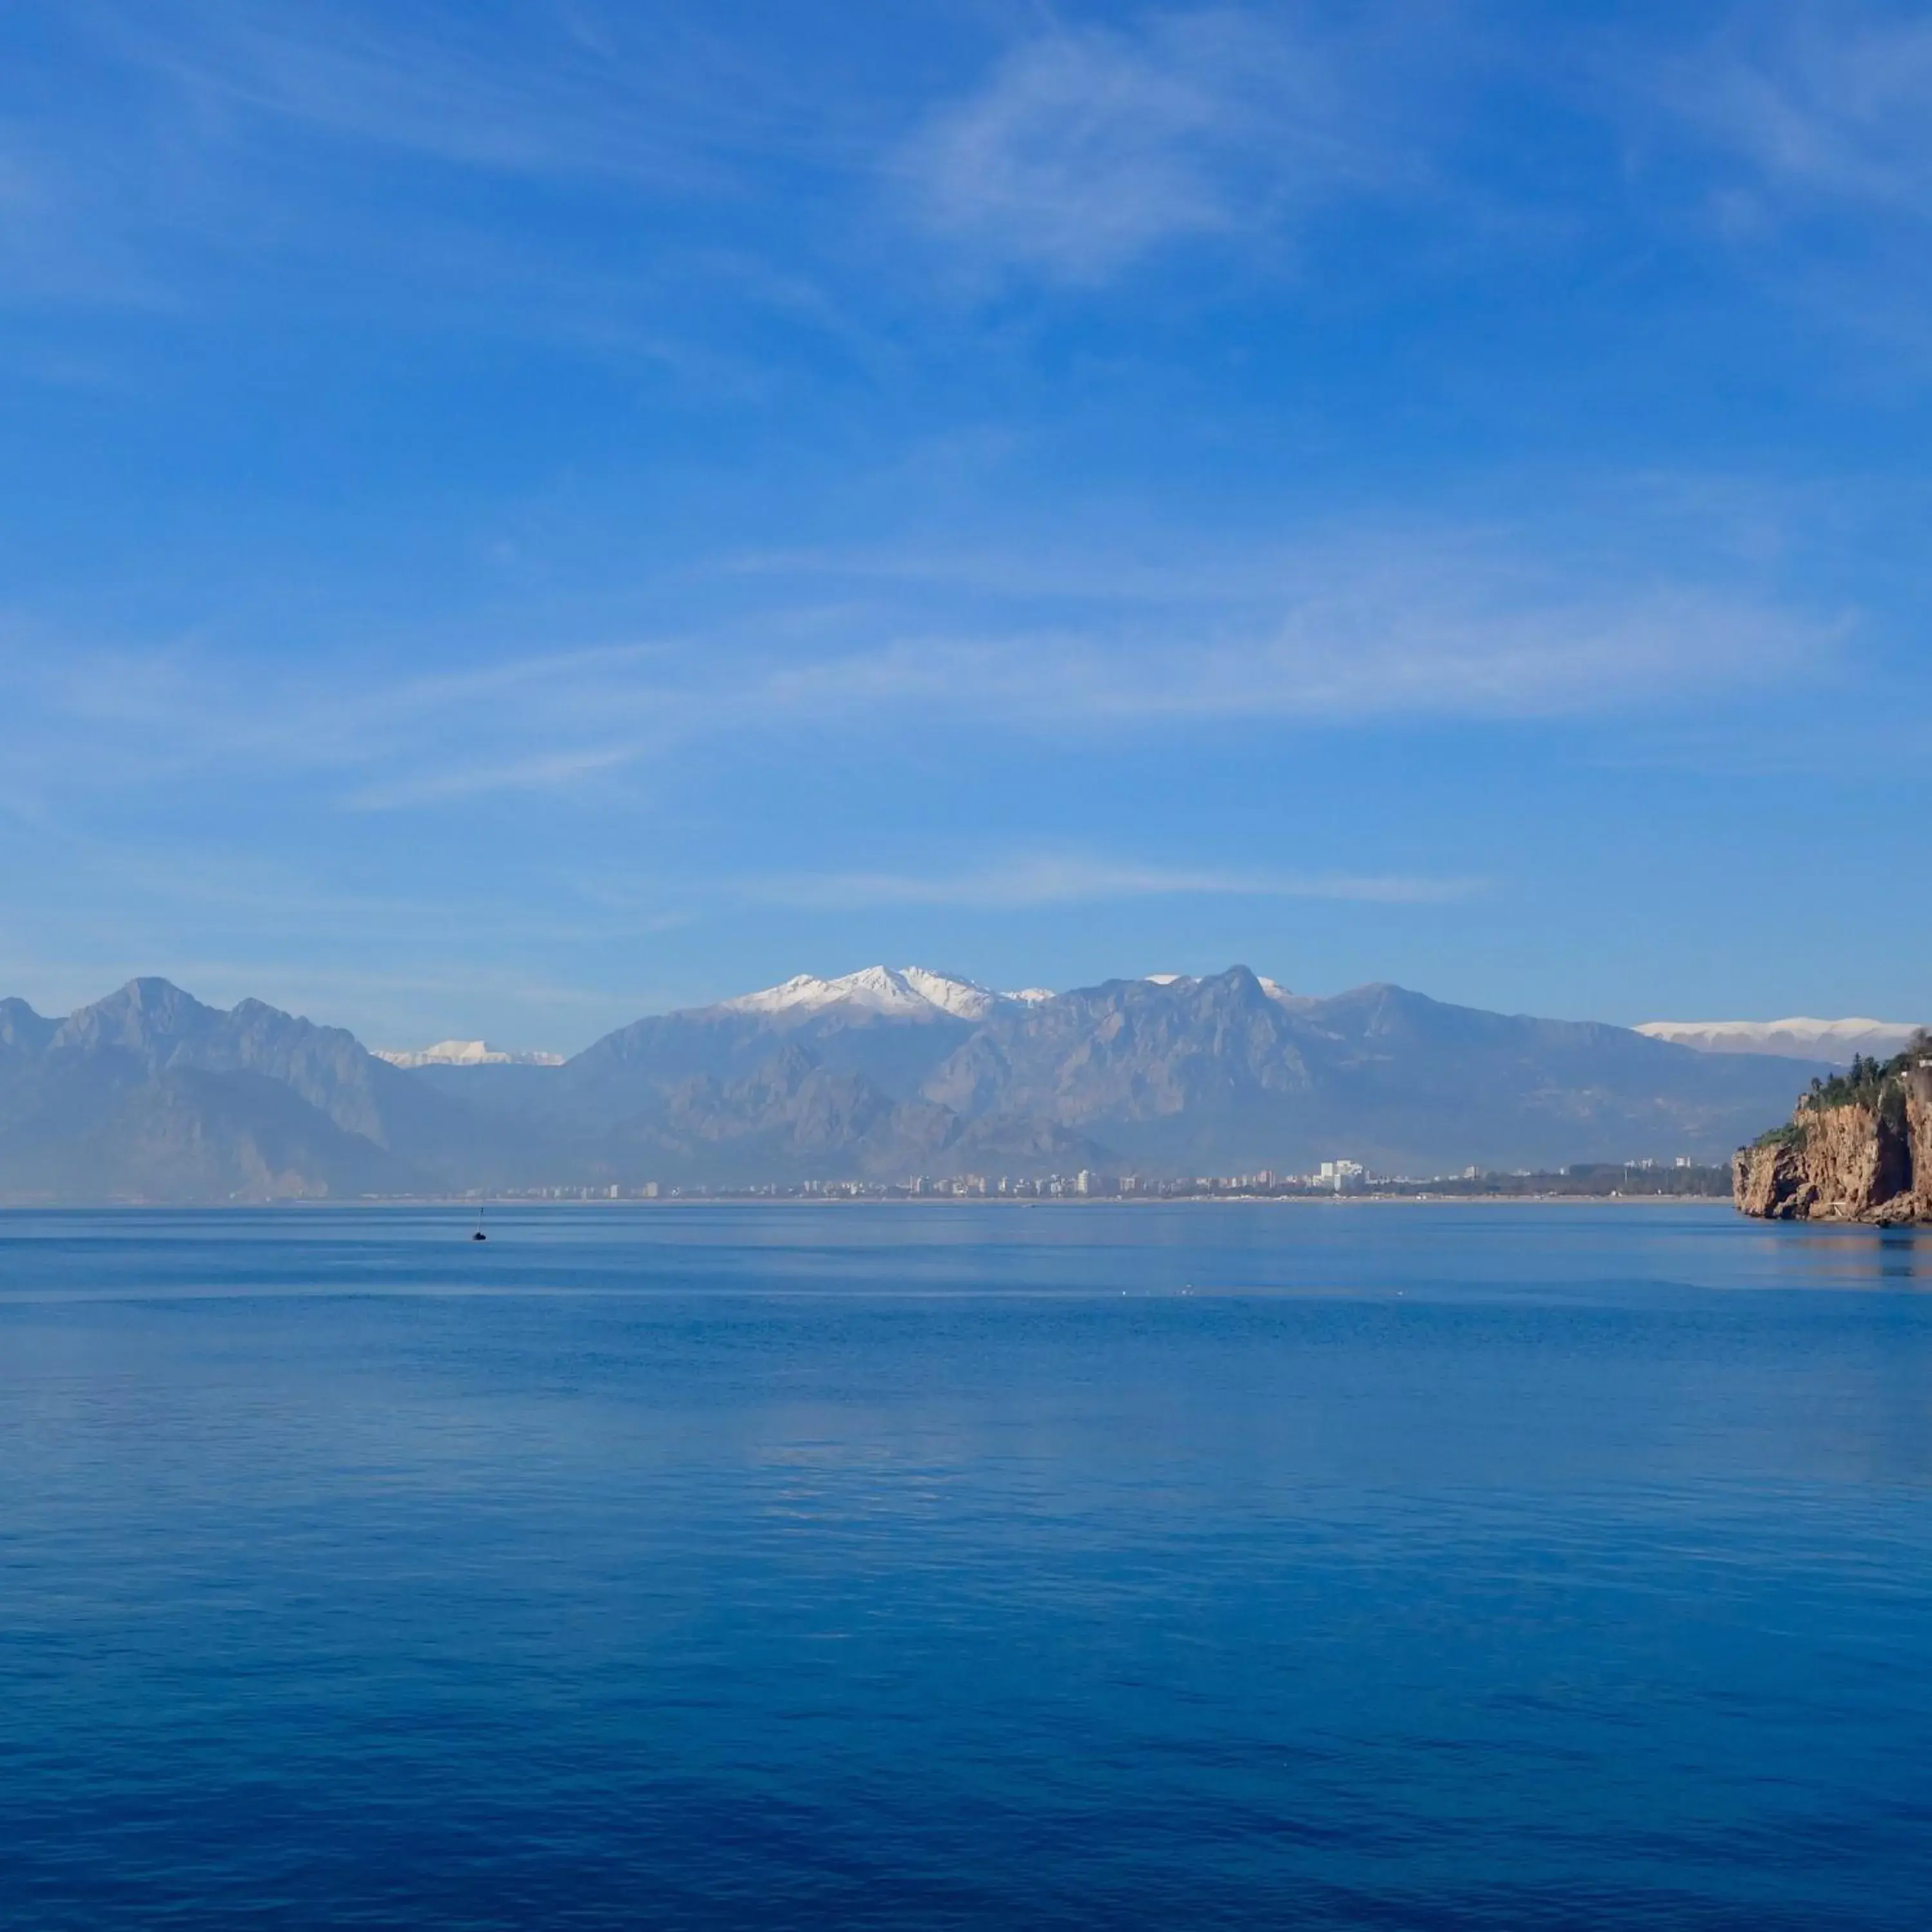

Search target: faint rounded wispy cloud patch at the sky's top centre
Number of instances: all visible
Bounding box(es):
[904,10,1410,282]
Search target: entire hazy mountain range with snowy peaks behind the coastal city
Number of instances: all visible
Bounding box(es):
[0,966,1822,1202]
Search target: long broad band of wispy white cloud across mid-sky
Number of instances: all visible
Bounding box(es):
[0,514,1849,811]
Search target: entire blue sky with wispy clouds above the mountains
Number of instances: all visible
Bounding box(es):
[0,0,1932,1049]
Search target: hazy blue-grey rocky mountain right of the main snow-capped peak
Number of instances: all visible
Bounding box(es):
[908,966,1808,1173]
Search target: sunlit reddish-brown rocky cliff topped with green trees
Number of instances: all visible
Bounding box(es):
[1731,1063,1932,1223]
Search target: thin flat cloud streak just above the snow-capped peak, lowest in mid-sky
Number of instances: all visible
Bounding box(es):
[738,854,1486,912]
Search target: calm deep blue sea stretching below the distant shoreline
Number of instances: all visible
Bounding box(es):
[0,1206,1932,1932]
